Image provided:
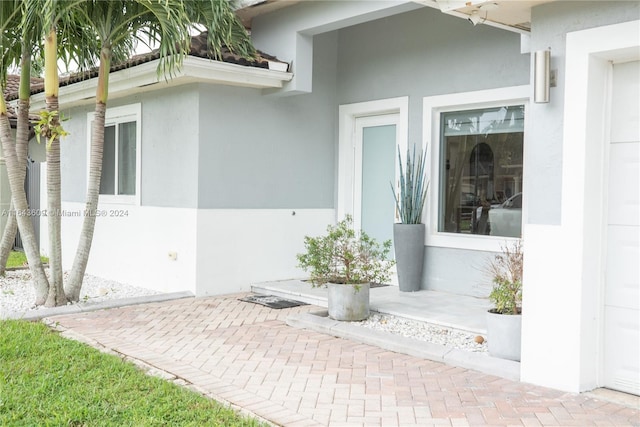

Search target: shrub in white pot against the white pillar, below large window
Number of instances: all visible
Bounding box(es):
[486,240,523,361]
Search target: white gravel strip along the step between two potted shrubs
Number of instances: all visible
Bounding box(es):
[356,313,488,353]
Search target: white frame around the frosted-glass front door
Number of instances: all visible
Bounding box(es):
[336,96,409,225]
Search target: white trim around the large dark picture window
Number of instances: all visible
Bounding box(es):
[422,85,530,252]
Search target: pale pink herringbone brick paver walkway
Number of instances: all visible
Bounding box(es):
[47,295,640,426]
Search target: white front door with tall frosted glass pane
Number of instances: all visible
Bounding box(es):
[353,114,399,249]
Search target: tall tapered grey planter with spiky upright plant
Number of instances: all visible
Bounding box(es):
[391,146,429,292]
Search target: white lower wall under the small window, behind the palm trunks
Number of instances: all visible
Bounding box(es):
[40,203,196,293]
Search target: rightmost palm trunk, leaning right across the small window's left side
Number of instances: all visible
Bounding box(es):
[66,47,111,301]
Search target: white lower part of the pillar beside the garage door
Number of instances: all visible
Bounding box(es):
[520,224,584,392]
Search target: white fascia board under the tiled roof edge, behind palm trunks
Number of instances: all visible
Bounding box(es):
[25,56,293,111]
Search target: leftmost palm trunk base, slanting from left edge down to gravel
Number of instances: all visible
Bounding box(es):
[0,95,49,305]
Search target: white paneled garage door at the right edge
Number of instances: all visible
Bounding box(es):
[603,61,640,395]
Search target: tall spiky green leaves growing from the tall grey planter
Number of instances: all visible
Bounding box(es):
[390,145,429,224]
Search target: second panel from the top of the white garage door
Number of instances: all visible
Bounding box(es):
[608,142,640,225]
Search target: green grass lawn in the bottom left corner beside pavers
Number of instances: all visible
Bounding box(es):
[0,320,263,426]
